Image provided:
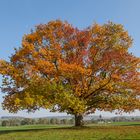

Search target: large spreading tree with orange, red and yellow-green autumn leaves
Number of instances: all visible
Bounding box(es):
[0,20,140,126]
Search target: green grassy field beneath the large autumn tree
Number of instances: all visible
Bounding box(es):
[0,122,140,140]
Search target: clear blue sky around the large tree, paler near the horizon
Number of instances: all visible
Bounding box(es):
[0,0,140,117]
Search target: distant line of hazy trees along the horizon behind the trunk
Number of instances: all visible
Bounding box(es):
[0,115,140,126]
